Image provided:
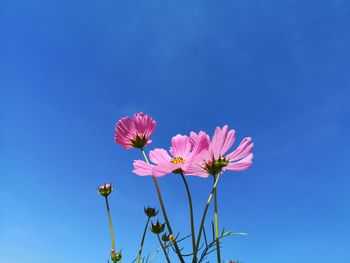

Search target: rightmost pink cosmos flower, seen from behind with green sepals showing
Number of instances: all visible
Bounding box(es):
[187,125,254,177]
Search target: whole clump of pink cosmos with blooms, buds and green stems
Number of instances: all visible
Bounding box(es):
[98,112,254,263]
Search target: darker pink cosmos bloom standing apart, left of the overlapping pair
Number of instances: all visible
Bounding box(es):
[114,112,156,149]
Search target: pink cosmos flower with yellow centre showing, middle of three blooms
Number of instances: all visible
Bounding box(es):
[133,133,209,177]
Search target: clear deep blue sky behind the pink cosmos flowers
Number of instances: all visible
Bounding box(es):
[0,0,350,263]
